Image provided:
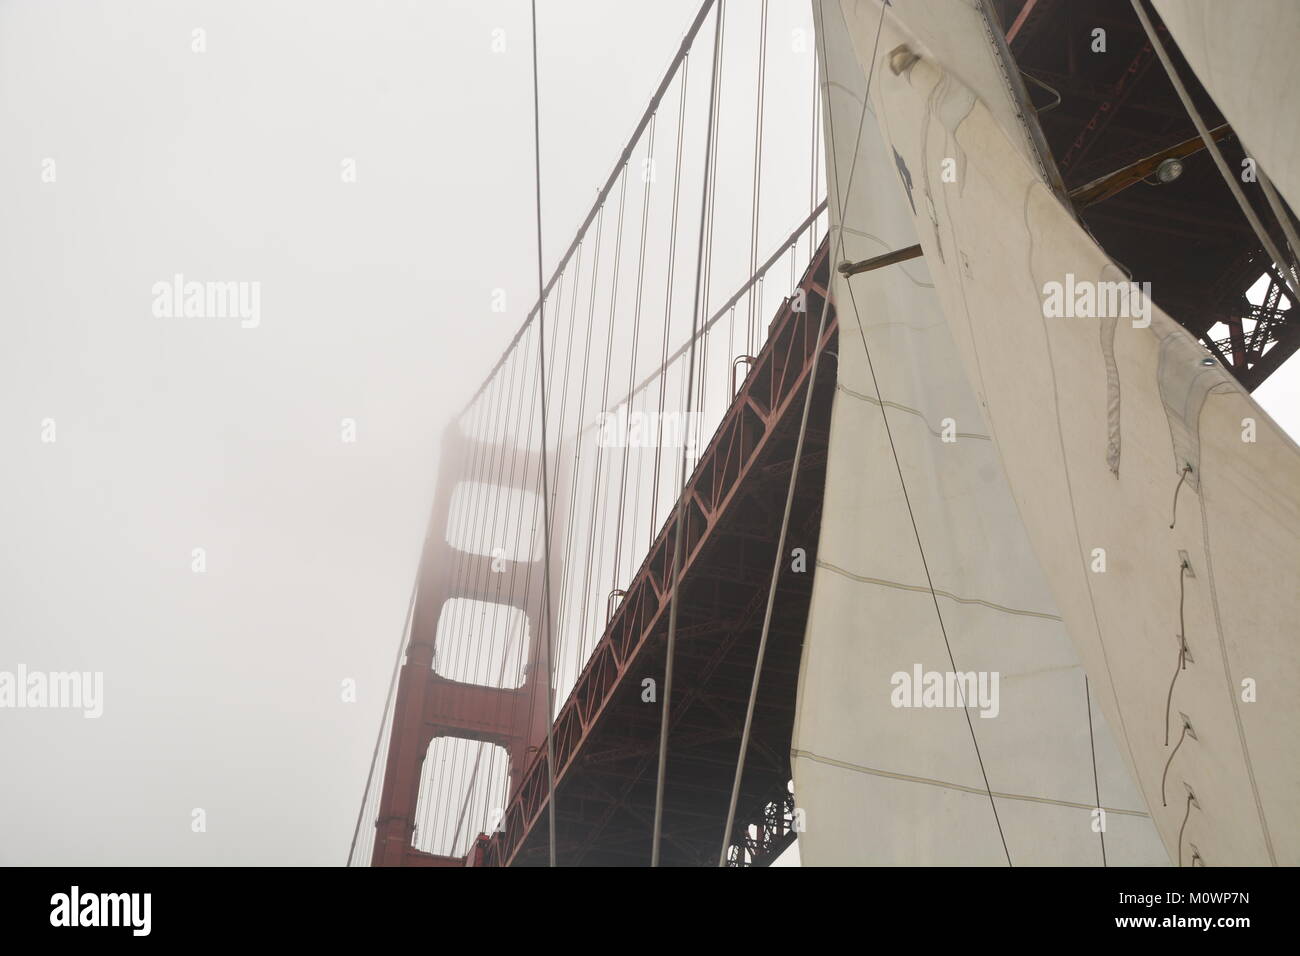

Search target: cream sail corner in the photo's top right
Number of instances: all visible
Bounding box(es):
[1156,0,1300,206]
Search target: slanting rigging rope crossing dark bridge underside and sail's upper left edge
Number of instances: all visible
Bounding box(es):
[718,4,889,866]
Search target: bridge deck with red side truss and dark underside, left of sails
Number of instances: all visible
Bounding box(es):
[488,246,835,865]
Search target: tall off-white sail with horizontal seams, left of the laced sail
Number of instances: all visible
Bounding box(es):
[793,3,1167,865]
